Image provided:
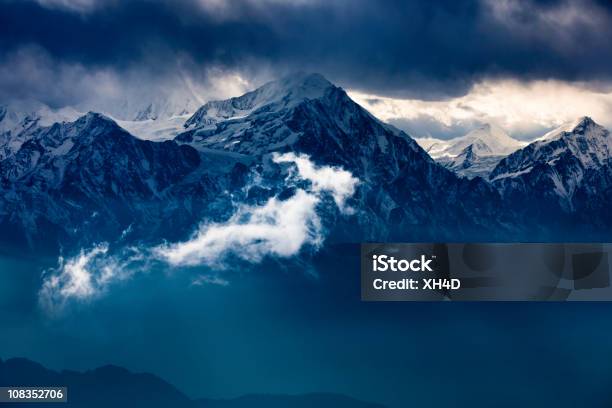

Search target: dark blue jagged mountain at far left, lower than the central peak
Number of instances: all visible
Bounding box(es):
[0,113,249,249]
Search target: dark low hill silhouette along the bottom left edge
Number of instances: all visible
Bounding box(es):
[0,358,383,408]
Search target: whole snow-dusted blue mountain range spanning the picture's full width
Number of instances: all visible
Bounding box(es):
[0,73,612,251]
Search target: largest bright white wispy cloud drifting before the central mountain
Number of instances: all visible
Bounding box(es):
[154,153,358,267]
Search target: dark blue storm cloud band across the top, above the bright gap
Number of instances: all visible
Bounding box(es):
[0,0,612,99]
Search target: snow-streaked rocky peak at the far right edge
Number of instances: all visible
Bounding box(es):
[489,117,612,235]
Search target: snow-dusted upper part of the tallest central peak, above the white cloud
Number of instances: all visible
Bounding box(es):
[176,74,431,166]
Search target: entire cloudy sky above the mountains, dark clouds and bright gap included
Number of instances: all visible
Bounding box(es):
[0,0,612,138]
